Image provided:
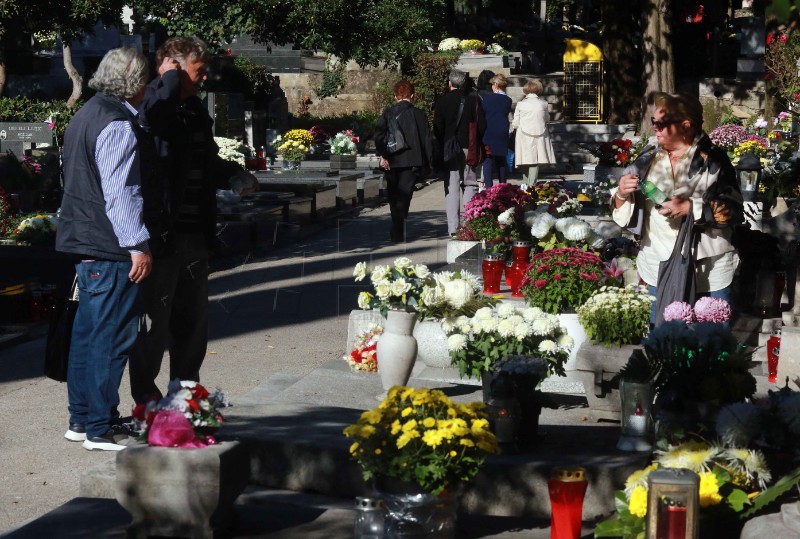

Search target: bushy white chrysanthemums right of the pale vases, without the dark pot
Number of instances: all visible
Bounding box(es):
[442,304,575,377]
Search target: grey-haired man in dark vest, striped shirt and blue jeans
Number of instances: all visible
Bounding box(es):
[56,49,153,451]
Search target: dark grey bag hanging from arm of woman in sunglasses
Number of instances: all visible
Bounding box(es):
[656,211,698,326]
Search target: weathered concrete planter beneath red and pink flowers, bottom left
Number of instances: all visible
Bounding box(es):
[116,442,250,539]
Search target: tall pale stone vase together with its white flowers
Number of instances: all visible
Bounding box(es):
[353,256,434,390]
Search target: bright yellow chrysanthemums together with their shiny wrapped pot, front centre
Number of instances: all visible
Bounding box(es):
[344,386,497,537]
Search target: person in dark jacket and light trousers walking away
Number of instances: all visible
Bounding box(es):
[433,69,486,237]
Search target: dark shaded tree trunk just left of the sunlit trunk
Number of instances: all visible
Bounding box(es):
[601,0,643,124]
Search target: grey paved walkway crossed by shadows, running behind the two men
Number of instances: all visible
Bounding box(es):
[0,177,576,533]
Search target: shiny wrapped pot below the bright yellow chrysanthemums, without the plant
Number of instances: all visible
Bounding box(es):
[375,477,456,539]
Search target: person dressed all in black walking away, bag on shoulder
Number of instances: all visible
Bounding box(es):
[375,80,432,243]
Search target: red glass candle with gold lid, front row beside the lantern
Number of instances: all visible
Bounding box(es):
[547,467,587,539]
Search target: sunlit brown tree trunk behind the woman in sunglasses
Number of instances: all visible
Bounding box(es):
[641,0,675,136]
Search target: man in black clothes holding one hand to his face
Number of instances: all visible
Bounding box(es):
[130,37,257,403]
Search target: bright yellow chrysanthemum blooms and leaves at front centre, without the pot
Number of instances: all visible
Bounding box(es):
[344,386,497,495]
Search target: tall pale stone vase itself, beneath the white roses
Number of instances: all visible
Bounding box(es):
[378,311,417,391]
